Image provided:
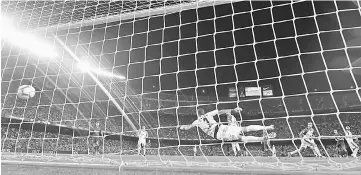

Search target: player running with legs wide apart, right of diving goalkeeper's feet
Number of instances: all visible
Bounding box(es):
[288,122,323,157]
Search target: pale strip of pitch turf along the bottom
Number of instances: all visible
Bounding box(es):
[1,153,361,175]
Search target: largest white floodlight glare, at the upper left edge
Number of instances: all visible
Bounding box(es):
[0,16,57,57]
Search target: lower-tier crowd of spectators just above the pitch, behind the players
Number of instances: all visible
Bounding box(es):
[1,119,360,157]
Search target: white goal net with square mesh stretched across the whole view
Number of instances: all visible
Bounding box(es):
[1,0,361,172]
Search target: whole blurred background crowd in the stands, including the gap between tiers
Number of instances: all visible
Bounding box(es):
[1,91,361,156]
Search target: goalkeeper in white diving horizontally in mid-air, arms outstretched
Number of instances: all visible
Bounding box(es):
[180,108,275,142]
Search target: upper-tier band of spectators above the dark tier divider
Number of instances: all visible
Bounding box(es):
[2,91,361,123]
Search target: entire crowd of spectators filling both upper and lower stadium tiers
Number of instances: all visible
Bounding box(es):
[1,92,361,159]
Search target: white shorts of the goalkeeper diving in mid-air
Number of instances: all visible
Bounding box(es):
[214,125,242,141]
